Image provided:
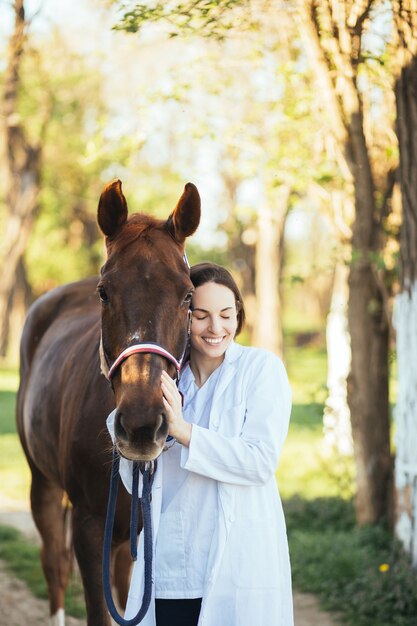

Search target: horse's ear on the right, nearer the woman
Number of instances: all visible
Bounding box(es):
[167,183,201,243]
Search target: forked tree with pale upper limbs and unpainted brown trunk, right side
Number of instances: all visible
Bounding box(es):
[290,0,395,524]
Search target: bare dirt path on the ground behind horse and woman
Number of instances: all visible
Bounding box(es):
[0,511,340,626]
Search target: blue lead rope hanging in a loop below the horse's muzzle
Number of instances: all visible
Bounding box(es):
[102,449,156,626]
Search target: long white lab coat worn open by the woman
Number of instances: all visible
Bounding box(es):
[108,343,293,626]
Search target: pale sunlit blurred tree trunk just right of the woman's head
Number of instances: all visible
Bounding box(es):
[254,185,290,357]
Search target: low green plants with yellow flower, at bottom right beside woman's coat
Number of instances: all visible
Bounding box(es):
[284,498,417,626]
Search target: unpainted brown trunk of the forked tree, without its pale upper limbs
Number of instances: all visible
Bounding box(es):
[348,101,392,524]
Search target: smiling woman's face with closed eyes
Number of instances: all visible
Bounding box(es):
[191,283,237,359]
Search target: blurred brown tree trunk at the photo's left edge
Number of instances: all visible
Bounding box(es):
[0,0,41,356]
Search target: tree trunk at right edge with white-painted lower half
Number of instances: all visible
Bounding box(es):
[394,50,417,566]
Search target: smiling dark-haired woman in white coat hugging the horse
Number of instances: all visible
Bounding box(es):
[111,263,293,626]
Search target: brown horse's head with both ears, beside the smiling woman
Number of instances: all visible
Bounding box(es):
[97,181,200,461]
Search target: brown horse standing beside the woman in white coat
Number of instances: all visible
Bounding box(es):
[17,181,200,626]
